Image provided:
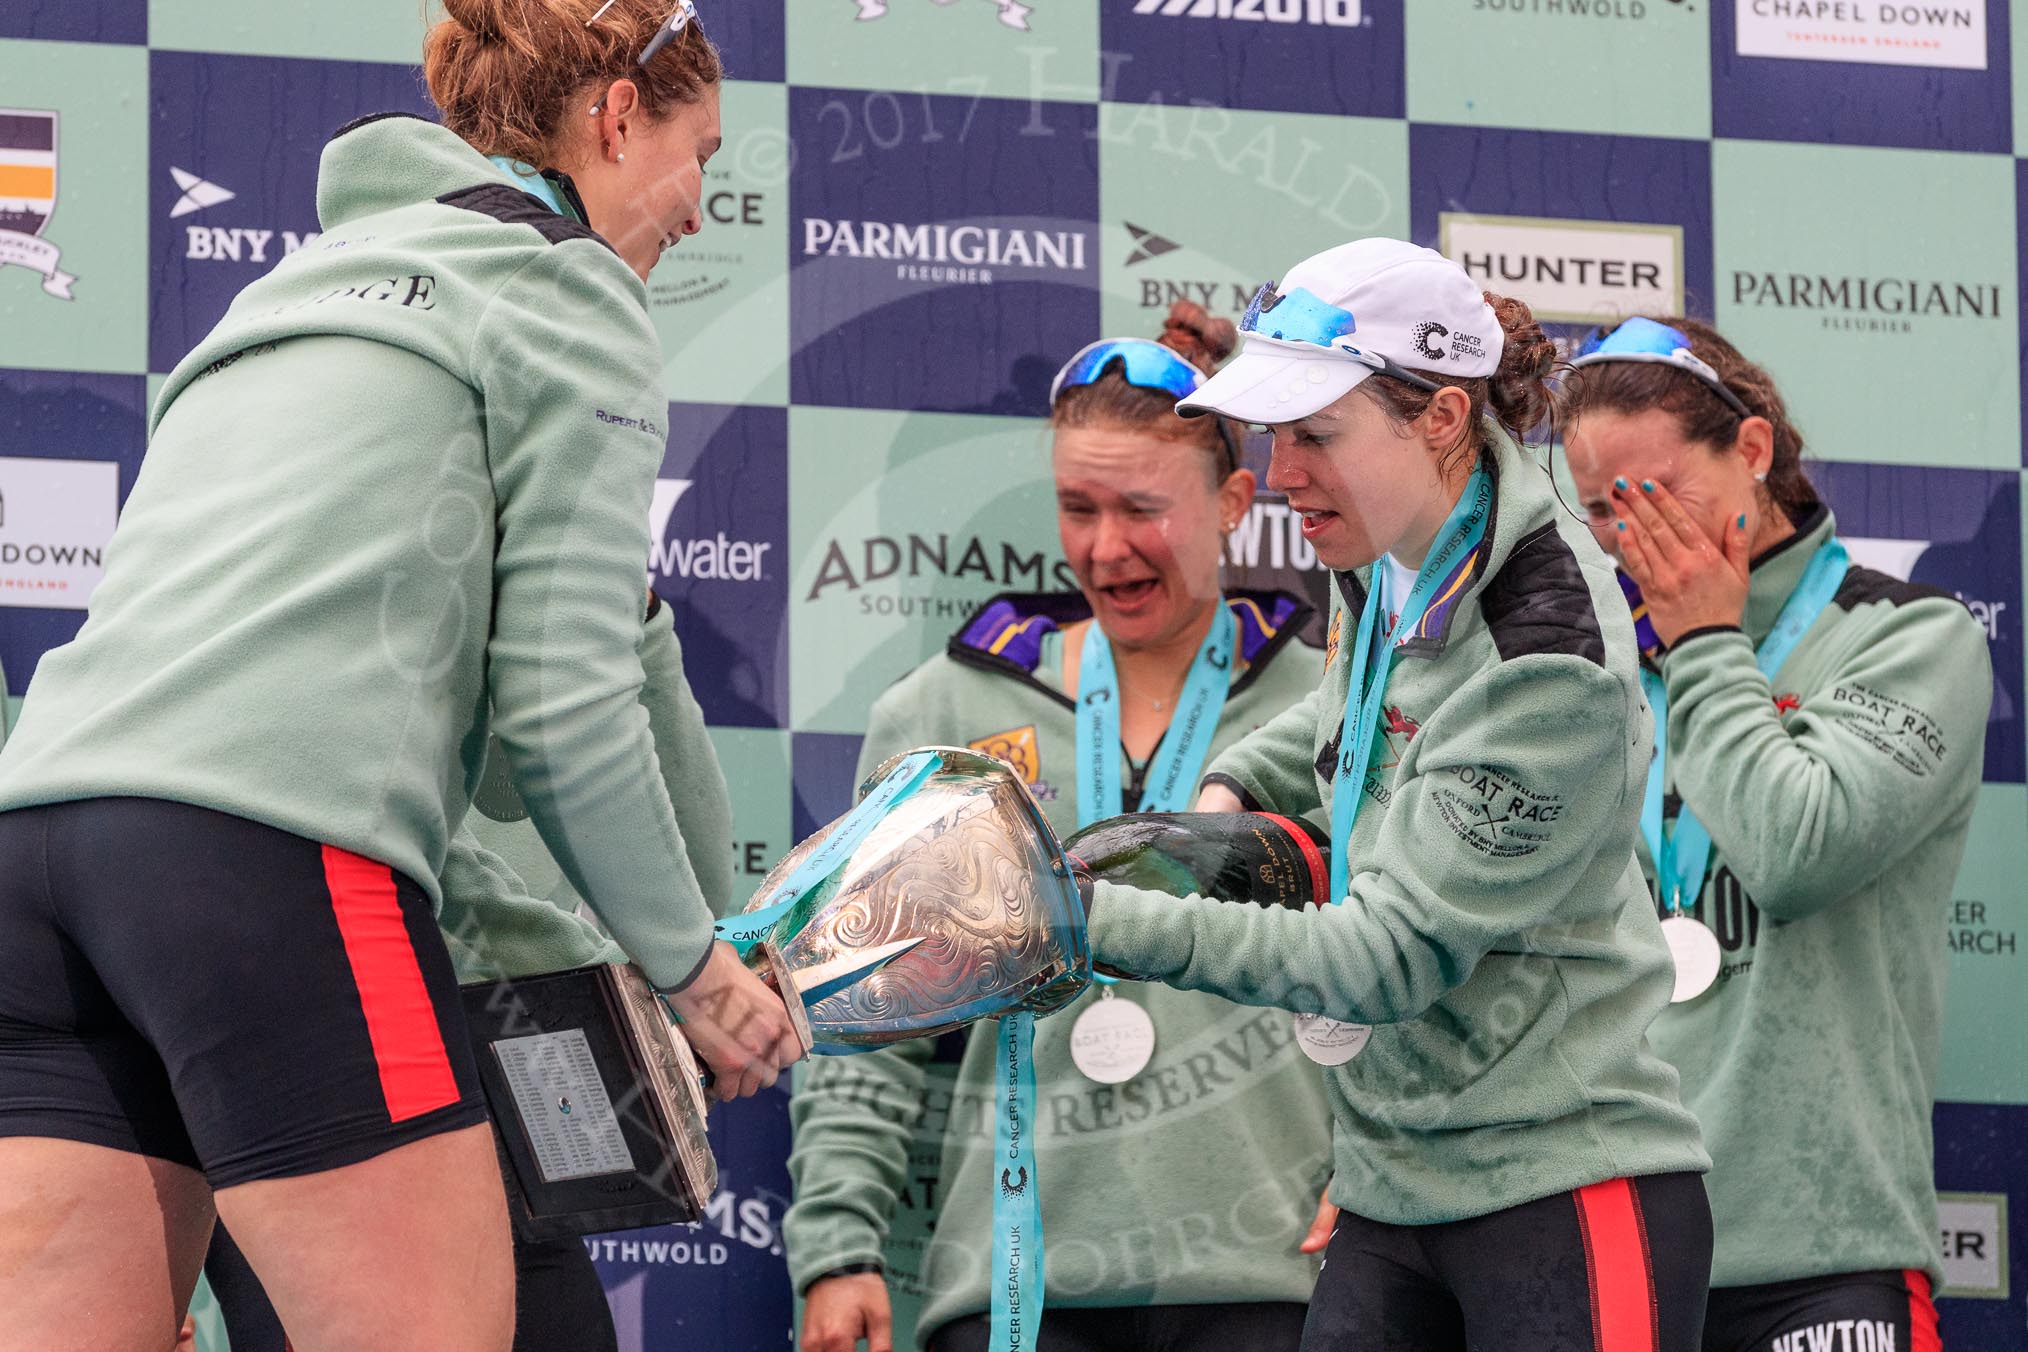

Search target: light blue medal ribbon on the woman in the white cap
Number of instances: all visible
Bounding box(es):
[1330,470,1493,906]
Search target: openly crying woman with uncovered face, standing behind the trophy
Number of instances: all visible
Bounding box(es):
[785,306,1330,1352]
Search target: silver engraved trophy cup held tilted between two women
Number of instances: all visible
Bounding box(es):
[748,746,1091,1054]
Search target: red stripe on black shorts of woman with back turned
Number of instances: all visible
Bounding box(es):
[324,845,458,1123]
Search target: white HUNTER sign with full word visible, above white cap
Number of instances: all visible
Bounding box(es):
[1438,211,1683,324]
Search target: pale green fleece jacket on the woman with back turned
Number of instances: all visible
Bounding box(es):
[0,116,712,987]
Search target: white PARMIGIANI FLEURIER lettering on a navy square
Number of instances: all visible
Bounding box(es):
[803,217,1091,286]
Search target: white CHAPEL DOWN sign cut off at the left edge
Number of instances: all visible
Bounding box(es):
[0,456,120,610]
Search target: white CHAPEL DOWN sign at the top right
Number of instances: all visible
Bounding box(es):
[1734,0,1985,71]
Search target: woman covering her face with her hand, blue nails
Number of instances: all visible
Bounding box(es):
[1562,318,1991,1352]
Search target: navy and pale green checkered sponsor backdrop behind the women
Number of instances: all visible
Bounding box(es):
[0,0,2028,1352]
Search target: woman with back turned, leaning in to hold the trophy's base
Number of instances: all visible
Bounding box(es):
[0,0,799,1352]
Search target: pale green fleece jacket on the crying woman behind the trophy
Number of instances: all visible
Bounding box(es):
[783,594,1330,1344]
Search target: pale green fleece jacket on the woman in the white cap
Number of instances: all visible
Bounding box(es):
[1091,440,1710,1224]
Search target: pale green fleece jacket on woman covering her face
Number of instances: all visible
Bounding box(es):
[1643,507,1994,1287]
